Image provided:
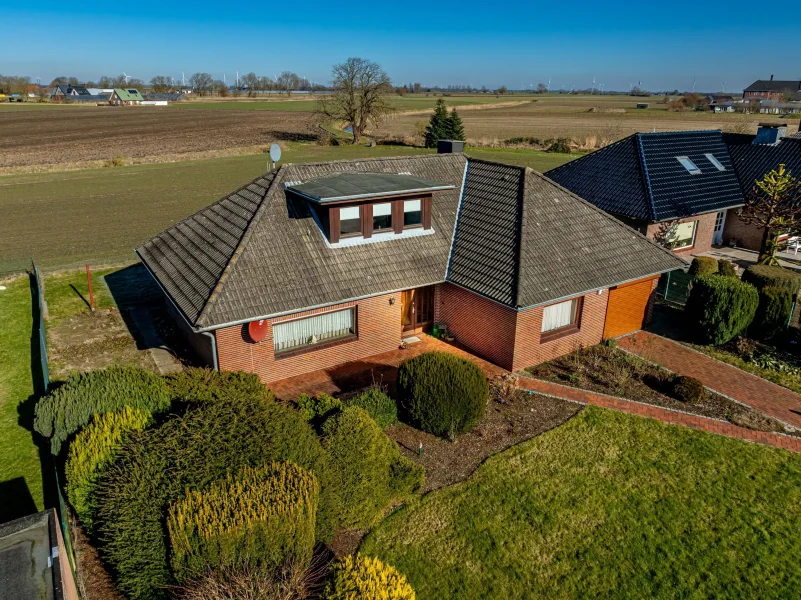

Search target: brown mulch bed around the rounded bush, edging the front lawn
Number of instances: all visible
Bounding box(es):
[329,390,582,556]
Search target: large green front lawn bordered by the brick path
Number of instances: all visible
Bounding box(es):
[361,407,801,600]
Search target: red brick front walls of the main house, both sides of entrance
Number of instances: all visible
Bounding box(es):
[215,283,646,383]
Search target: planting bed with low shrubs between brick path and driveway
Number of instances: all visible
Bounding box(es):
[527,346,801,437]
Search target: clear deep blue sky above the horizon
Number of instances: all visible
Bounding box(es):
[0,0,801,91]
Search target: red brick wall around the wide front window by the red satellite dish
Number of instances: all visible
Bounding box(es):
[215,293,401,383]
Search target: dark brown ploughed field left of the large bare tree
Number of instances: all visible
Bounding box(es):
[0,107,315,168]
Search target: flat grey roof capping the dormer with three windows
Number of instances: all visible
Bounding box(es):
[286,172,456,204]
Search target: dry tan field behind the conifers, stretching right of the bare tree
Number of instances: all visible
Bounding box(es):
[374,98,798,148]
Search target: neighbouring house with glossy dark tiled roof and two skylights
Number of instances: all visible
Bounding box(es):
[546,131,745,254]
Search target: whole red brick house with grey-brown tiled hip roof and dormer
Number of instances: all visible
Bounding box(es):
[136,153,686,383]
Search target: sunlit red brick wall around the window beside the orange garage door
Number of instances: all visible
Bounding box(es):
[513,290,609,371]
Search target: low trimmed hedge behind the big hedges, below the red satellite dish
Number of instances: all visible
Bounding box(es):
[166,367,275,403]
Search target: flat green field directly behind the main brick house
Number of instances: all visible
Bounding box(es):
[0,143,575,273]
